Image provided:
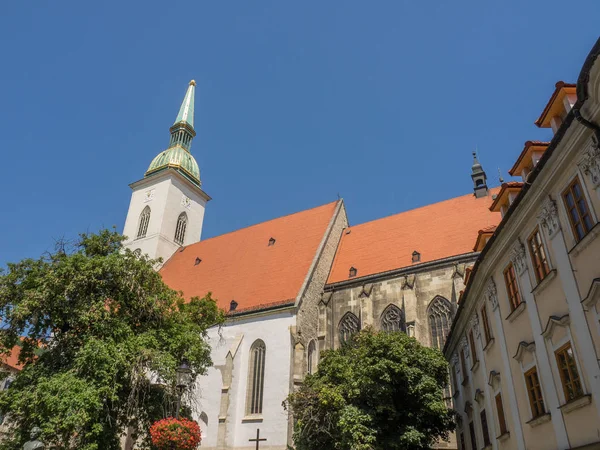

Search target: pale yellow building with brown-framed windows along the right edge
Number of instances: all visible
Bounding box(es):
[444,41,600,450]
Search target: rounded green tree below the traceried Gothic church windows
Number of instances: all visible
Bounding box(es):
[285,329,454,450]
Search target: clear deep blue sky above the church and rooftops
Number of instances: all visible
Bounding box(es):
[0,0,600,267]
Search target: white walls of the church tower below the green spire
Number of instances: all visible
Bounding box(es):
[123,169,208,261]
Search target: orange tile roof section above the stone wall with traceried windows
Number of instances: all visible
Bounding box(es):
[327,188,500,283]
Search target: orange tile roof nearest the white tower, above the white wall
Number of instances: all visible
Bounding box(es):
[160,201,341,312]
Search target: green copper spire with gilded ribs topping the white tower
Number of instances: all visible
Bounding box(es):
[144,80,201,186]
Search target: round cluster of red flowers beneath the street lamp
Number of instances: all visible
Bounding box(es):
[150,417,202,450]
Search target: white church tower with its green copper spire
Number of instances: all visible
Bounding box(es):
[123,80,210,261]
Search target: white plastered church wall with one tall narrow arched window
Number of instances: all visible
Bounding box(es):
[194,310,296,450]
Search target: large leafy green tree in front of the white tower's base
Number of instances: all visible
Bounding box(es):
[0,230,223,450]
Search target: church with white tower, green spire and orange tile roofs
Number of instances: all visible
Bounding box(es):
[123,81,501,450]
